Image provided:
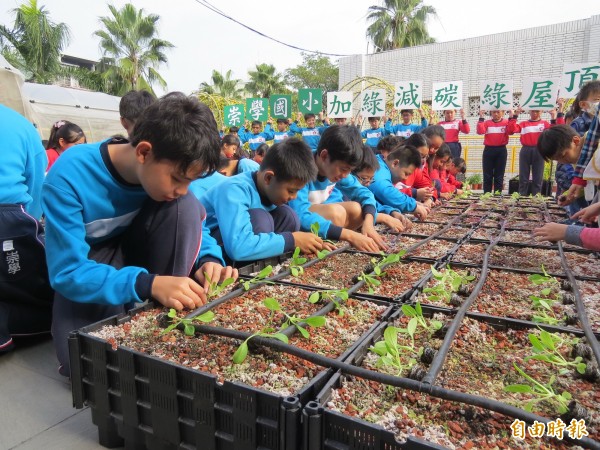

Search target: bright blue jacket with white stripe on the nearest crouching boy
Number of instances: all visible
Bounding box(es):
[42,141,224,305]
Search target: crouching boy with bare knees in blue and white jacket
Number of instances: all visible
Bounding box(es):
[290,125,386,252]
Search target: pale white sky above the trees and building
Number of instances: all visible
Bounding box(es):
[0,0,600,93]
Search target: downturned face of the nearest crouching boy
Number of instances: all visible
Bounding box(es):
[137,151,203,202]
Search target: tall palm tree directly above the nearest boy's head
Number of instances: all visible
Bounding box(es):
[94,3,174,95]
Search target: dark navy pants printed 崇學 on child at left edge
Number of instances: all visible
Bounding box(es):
[0,204,54,346]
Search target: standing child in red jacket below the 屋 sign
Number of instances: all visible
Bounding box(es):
[508,103,565,195]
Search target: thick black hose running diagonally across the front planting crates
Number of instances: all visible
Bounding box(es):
[188,325,600,450]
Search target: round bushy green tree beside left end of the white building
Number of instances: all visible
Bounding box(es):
[285,53,340,92]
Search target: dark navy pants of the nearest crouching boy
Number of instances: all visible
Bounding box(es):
[52,193,204,376]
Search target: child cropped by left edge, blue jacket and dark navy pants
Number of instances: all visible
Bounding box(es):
[0,105,54,354]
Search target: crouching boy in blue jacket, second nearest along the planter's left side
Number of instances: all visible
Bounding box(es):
[202,138,333,261]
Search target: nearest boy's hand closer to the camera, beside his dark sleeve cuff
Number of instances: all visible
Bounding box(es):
[151,275,206,311]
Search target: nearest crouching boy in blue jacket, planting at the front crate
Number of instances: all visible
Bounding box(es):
[42,93,237,376]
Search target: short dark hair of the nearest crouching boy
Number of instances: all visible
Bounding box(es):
[130,92,221,174]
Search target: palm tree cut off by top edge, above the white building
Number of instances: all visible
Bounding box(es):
[367,0,437,52]
